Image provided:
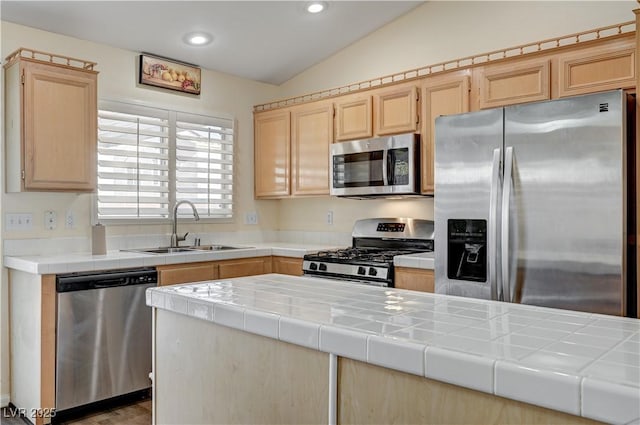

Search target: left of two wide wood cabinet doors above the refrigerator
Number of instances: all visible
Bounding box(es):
[478,58,551,109]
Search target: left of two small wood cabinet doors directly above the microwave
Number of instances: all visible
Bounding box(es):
[335,96,373,140]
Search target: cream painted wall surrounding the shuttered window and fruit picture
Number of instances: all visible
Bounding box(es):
[2,22,278,239]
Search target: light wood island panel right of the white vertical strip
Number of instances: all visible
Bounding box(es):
[337,357,600,425]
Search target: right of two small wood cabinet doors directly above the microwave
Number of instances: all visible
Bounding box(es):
[373,86,419,136]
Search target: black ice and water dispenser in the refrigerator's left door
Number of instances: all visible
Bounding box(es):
[447,219,487,282]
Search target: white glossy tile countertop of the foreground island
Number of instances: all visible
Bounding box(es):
[147,274,640,424]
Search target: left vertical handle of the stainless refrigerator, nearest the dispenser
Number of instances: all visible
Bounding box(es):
[487,148,503,300]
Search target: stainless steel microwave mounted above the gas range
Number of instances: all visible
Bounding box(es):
[330,133,420,198]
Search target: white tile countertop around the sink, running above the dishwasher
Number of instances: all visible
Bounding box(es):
[4,242,334,274]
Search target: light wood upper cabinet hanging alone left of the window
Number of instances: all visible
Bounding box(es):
[5,48,98,192]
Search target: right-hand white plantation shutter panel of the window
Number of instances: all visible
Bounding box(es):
[176,113,233,218]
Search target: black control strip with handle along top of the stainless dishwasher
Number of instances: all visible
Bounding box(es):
[56,267,158,292]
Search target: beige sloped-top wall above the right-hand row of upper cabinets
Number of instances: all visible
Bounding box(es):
[280,0,637,98]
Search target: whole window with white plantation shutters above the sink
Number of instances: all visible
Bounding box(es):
[97,102,238,220]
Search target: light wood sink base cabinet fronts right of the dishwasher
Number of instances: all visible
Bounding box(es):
[156,257,271,286]
